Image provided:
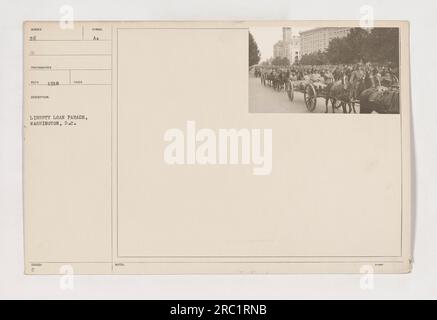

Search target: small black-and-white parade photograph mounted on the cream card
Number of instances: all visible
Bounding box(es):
[249,26,400,114]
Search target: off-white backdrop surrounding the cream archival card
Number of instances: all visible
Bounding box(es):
[5,0,437,299]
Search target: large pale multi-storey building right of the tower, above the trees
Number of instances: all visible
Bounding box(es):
[300,27,350,55]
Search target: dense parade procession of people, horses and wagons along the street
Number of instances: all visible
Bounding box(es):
[255,63,399,113]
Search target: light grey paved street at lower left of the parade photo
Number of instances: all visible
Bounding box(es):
[249,75,359,113]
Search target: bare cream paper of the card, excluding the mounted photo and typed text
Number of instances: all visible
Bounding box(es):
[24,22,410,273]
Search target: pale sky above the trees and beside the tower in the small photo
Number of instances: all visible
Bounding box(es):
[249,27,311,61]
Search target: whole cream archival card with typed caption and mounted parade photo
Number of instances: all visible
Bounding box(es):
[23,21,412,275]
